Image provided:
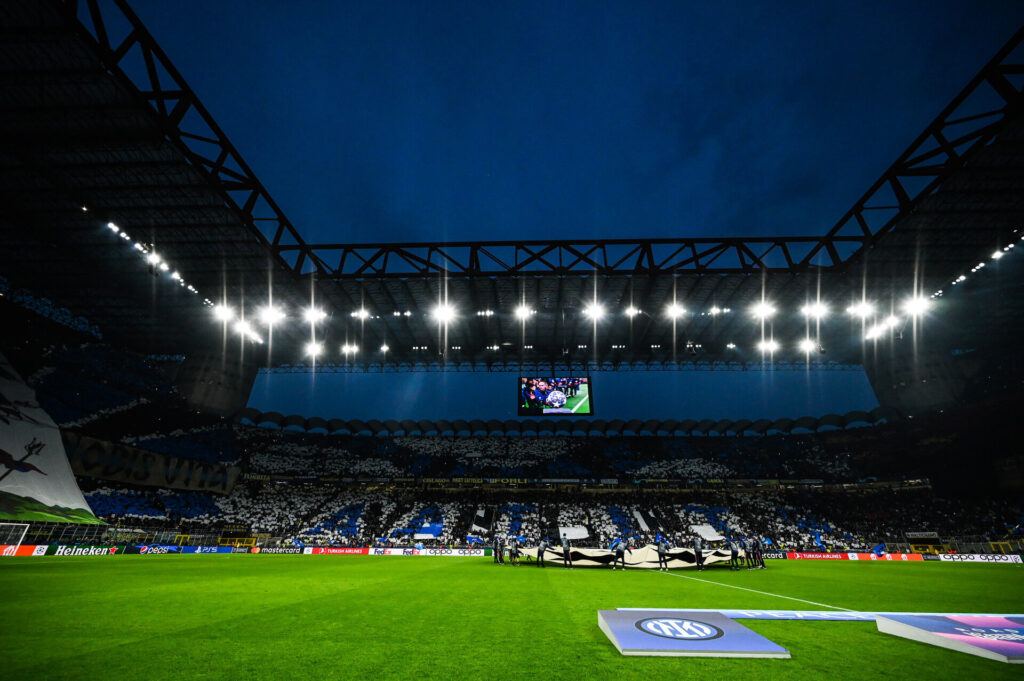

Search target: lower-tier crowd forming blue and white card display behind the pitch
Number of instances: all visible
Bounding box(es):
[72,483,1022,551]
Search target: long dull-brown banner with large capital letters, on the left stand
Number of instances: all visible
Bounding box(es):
[63,432,241,495]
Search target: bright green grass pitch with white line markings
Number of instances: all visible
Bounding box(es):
[0,555,1024,681]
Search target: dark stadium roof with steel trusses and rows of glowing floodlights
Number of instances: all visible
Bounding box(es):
[0,0,1024,370]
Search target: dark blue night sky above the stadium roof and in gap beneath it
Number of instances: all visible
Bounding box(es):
[132,0,1024,418]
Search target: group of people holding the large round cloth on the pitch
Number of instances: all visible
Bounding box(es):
[493,533,765,571]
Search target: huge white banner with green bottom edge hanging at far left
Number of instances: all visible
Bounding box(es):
[0,354,100,523]
